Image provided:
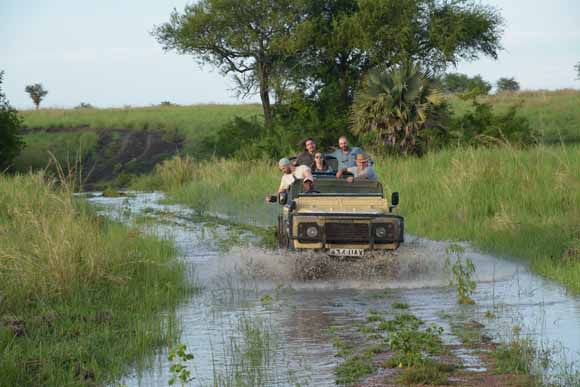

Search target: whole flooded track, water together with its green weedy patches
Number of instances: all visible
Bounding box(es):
[89,193,580,386]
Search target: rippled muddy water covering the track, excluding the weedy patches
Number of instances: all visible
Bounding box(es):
[89,193,580,386]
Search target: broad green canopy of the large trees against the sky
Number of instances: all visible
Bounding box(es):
[153,0,503,133]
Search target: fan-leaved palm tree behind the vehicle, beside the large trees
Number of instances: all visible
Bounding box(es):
[351,63,443,154]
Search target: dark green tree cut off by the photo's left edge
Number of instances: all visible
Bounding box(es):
[0,71,24,172]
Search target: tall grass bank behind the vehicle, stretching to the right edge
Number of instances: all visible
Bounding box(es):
[136,145,580,291]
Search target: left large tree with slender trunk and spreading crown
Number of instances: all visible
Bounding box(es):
[153,0,305,127]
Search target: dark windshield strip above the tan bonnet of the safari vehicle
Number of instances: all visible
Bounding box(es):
[290,176,383,197]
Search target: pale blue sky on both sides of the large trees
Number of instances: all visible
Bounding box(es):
[0,0,580,109]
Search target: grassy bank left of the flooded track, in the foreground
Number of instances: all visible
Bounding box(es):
[0,174,188,386]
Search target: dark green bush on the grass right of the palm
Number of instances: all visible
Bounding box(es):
[449,93,540,146]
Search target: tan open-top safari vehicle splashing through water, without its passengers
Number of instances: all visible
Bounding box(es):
[277,164,404,257]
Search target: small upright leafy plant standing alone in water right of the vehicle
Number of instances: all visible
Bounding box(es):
[445,243,477,304]
